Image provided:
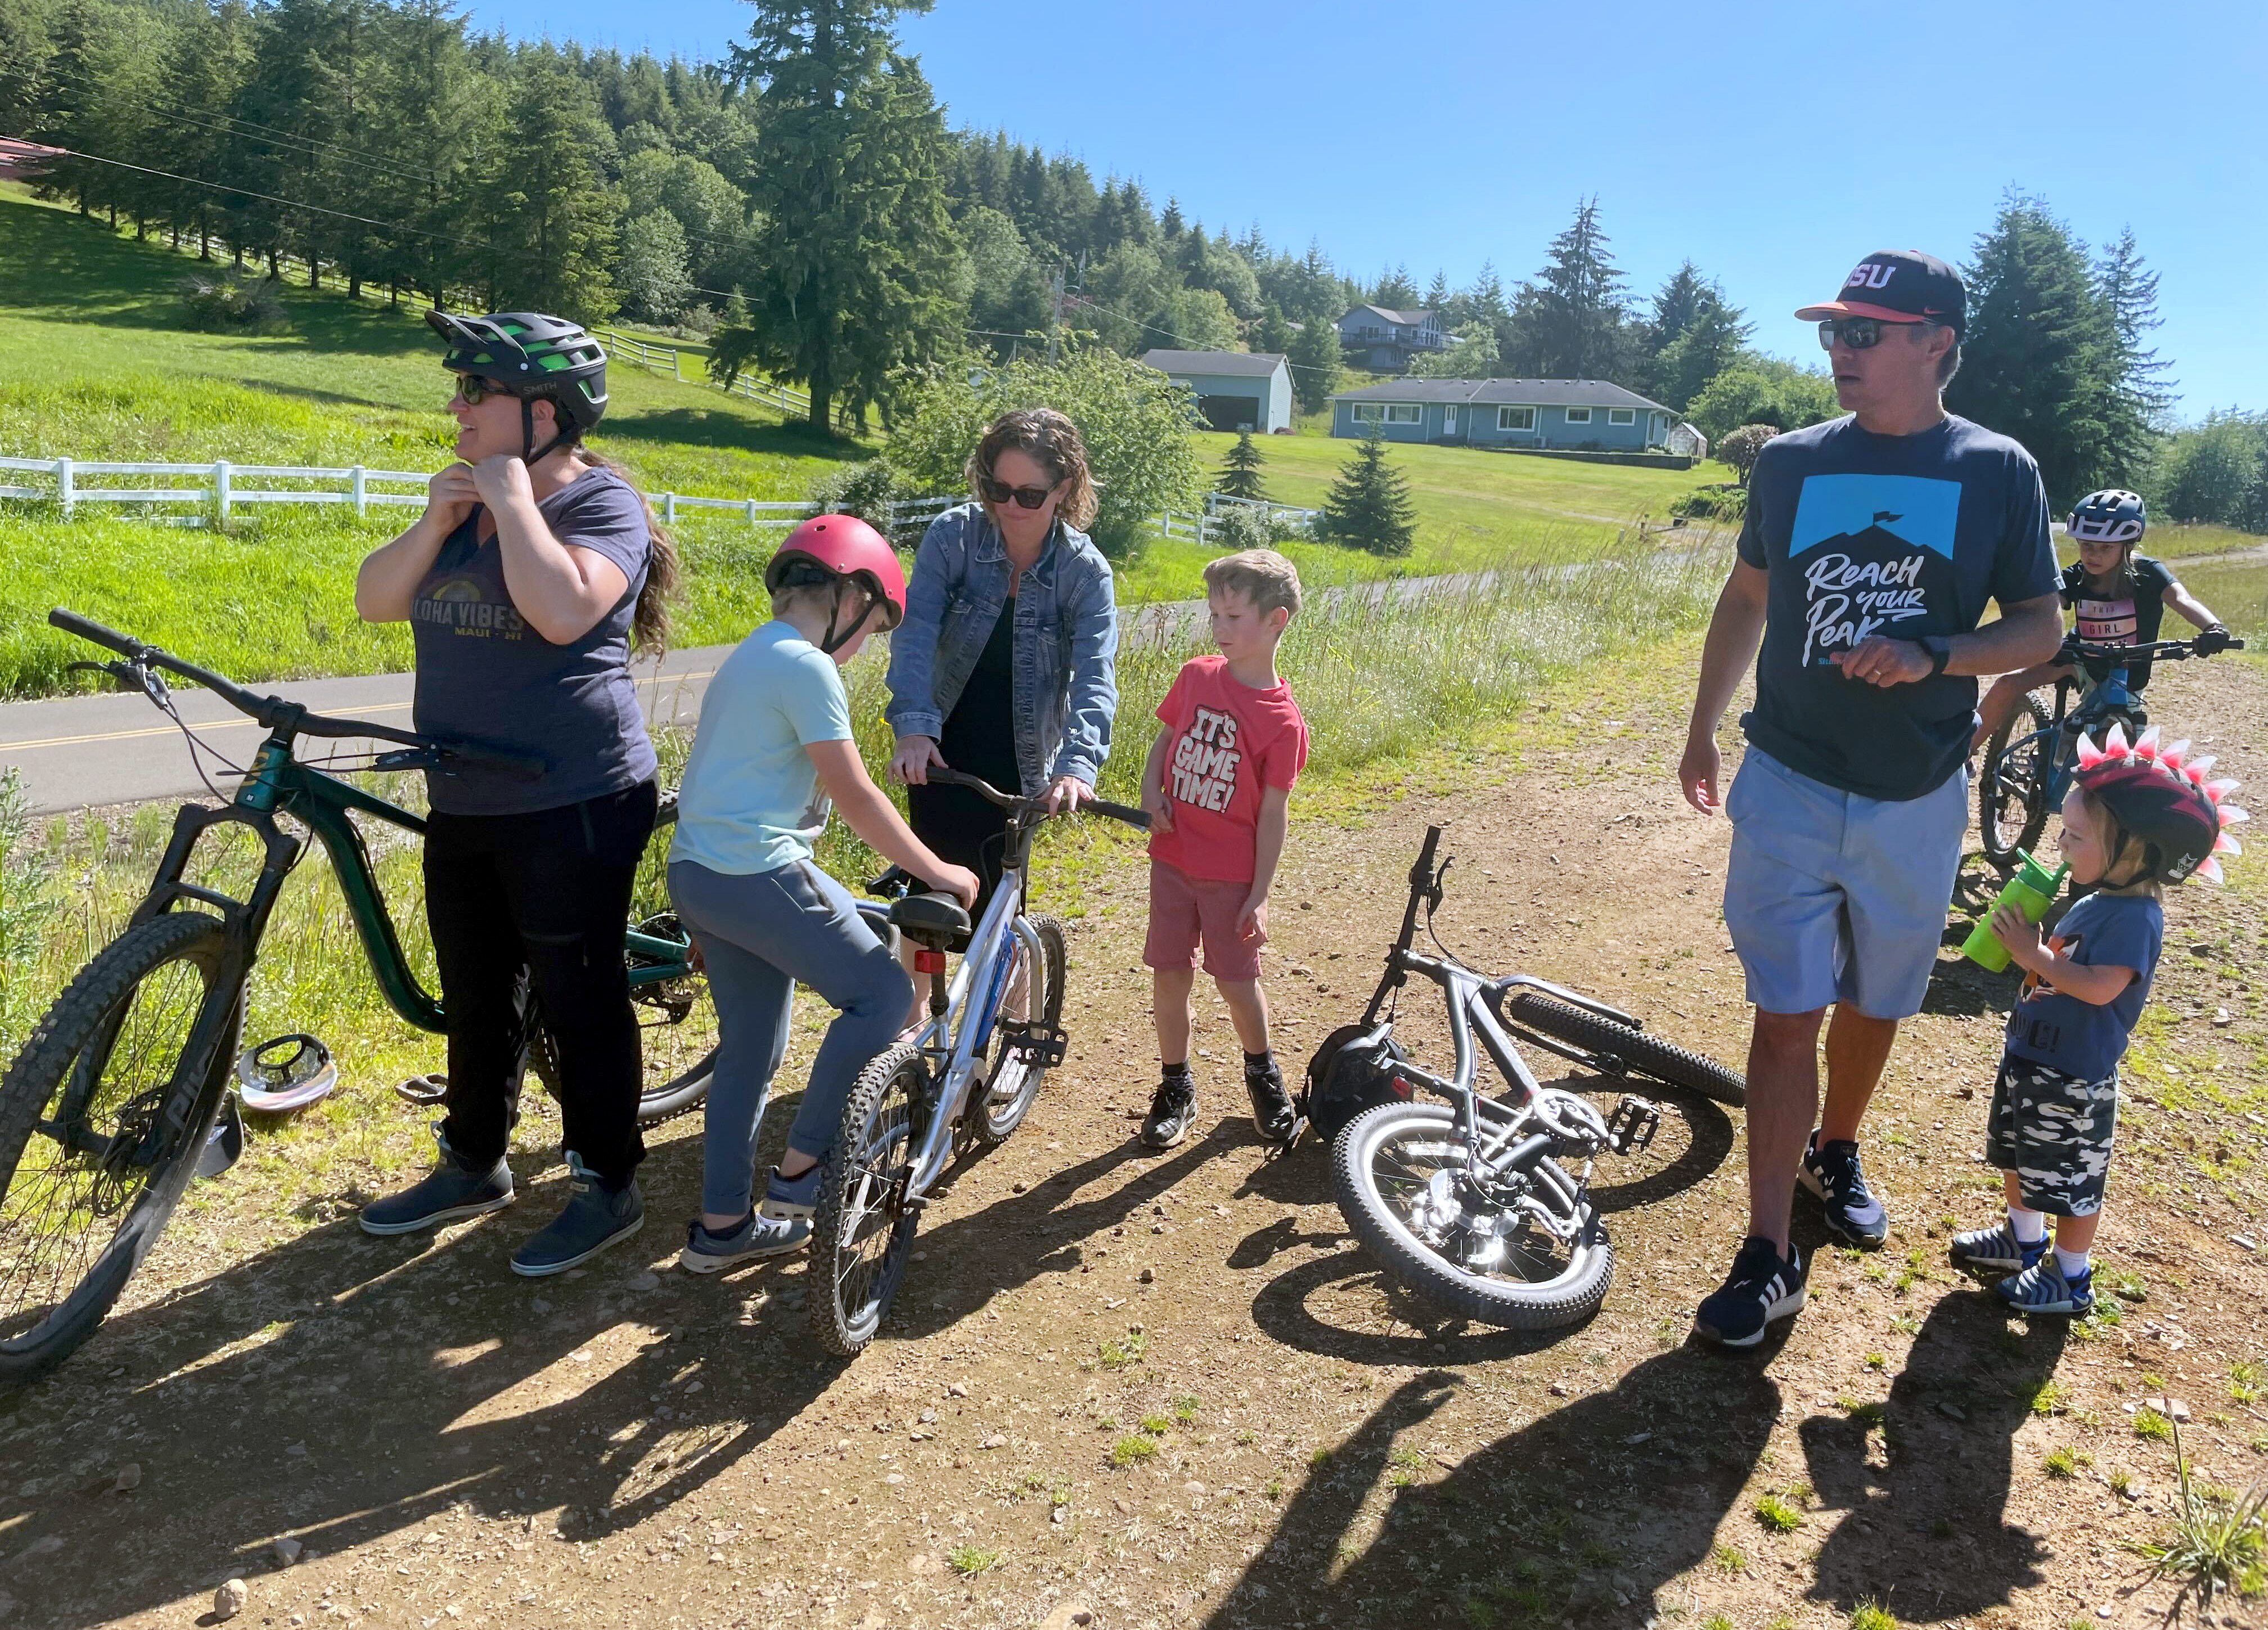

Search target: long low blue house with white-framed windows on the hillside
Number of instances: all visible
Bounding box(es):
[1331,379,1678,453]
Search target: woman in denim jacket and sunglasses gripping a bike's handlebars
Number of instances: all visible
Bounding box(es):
[884,408,1118,916]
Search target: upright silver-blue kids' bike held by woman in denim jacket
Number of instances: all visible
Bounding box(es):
[805,768,1150,1356]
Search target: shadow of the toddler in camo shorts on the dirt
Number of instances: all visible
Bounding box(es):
[1798,1290,2068,1623]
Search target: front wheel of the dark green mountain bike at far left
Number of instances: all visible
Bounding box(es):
[0,911,242,1381]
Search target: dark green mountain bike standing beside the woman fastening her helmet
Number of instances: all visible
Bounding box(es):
[0,610,717,1379]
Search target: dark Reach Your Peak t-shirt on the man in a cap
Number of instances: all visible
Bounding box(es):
[1740,415,2057,800]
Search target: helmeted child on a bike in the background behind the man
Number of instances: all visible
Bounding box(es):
[1969,488,2229,753]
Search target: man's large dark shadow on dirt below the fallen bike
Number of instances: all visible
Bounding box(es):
[1207,1351,1780,1630]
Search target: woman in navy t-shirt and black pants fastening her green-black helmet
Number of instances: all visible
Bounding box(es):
[354,310,676,1276]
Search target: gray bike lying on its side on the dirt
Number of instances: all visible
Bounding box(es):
[1308,827,1749,1331]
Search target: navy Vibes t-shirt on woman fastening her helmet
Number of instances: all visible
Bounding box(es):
[411,469,655,814]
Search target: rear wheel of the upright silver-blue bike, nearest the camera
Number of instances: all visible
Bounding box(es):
[805,1041,930,1358]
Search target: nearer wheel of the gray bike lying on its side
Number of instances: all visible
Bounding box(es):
[1331,1104,1615,1331]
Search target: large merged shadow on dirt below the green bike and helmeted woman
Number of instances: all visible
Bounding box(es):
[0,1138,844,1623]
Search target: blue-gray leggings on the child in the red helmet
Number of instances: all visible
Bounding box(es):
[669,859,914,1217]
